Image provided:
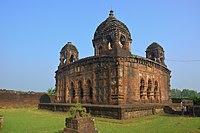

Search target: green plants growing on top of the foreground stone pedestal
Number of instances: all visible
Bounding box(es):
[68,103,91,119]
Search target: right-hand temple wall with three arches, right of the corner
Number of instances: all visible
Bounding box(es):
[119,58,170,104]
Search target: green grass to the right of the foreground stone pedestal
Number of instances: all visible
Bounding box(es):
[96,115,200,133]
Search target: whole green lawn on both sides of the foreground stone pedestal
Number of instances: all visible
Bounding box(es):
[0,108,200,133]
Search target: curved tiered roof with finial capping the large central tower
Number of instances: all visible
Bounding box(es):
[94,10,131,40]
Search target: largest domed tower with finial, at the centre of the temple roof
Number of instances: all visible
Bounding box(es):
[92,10,132,56]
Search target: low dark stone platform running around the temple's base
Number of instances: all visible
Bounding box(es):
[39,103,168,119]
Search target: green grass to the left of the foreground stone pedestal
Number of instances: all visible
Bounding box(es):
[0,108,66,133]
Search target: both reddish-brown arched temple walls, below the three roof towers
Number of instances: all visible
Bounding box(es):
[56,56,170,105]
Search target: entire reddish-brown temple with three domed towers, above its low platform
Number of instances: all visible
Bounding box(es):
[55,10,171,105]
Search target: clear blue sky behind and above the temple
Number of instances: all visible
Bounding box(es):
[0,0,200,92]
